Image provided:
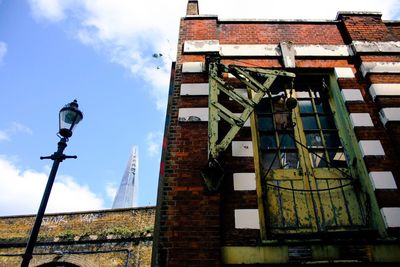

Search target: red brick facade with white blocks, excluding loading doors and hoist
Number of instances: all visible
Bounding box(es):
[153,1,400,266]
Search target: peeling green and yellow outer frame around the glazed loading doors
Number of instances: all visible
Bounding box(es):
[250,70,386,241]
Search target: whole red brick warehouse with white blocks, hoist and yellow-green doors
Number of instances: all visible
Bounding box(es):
[153,0,400,266]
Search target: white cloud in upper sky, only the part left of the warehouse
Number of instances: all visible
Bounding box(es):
[30,0,186,111]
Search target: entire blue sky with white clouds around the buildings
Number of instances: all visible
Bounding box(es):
[0,0,400,216]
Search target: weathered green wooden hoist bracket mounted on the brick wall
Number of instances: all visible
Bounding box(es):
[202,61,295,191]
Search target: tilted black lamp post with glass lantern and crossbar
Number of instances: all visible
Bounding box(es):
[21,100,83,267]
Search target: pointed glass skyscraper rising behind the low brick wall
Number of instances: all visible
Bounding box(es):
[112,146,139,209]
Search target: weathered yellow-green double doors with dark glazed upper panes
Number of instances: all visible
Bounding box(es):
[253,75,366,237]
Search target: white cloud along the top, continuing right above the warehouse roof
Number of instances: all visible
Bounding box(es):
[26,0,400,111]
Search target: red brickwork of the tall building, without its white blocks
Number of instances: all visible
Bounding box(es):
[153,5,400,266]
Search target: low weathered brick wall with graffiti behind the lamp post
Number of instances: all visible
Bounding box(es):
[0,207,155,267]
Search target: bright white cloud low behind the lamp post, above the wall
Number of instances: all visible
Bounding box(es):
[0,155,104,216]
